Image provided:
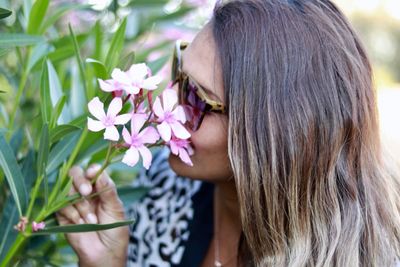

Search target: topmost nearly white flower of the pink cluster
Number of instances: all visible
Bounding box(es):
[111,63,161,95]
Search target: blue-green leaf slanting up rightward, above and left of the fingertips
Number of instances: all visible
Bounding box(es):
[46,132,80,174]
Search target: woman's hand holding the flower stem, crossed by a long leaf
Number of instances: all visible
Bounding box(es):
[57,165,129,267]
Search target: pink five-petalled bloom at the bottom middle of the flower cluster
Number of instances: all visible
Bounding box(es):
[122,114,160,169]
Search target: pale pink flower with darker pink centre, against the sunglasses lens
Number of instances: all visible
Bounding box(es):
[153,89,190,142]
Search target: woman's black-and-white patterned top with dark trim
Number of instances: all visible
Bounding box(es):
[127,150,214,267]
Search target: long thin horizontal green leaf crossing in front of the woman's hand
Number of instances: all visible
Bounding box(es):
[32,220,135,236]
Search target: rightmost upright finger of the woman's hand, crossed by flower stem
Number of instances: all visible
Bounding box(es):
[86,164,124,219]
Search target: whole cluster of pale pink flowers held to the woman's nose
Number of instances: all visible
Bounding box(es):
[88,63,193,169]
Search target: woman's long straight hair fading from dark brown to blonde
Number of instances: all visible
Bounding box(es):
[211,0,400,266]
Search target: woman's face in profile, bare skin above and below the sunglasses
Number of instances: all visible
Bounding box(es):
[169,25,232,181]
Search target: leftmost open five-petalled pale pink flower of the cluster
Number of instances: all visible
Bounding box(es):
[88,97,131,141]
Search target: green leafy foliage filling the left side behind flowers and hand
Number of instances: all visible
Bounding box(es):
[0,0,202,266]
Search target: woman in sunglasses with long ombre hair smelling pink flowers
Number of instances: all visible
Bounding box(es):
[58,0,400,266]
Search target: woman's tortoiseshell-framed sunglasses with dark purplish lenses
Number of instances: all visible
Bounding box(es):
[172,40,226,131]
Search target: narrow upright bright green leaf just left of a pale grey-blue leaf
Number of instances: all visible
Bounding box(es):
[40,60,53,123]
